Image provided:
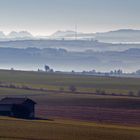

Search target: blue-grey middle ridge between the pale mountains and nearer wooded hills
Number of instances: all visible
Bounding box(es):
[0,39,140,52]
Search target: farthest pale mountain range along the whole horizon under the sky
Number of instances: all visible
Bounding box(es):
[0,29,140,43]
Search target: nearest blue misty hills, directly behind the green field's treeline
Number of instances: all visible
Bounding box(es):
[0,48,140,72]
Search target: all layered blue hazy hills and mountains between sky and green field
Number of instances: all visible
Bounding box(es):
[0,29,140,72]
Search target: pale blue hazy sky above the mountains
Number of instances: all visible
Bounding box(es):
[0,0,140,35]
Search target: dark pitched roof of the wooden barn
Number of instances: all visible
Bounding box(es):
[0,97,36,104]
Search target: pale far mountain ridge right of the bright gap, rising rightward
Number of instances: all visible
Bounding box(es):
[51,29,140,43]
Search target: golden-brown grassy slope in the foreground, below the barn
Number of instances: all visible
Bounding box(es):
[0,118,140,140]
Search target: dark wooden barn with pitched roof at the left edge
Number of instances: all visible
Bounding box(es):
[0,98,36,118]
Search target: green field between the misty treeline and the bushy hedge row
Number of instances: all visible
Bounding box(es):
[0,70,140,93]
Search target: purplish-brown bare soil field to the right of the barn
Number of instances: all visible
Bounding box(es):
[22,94,140,125]
